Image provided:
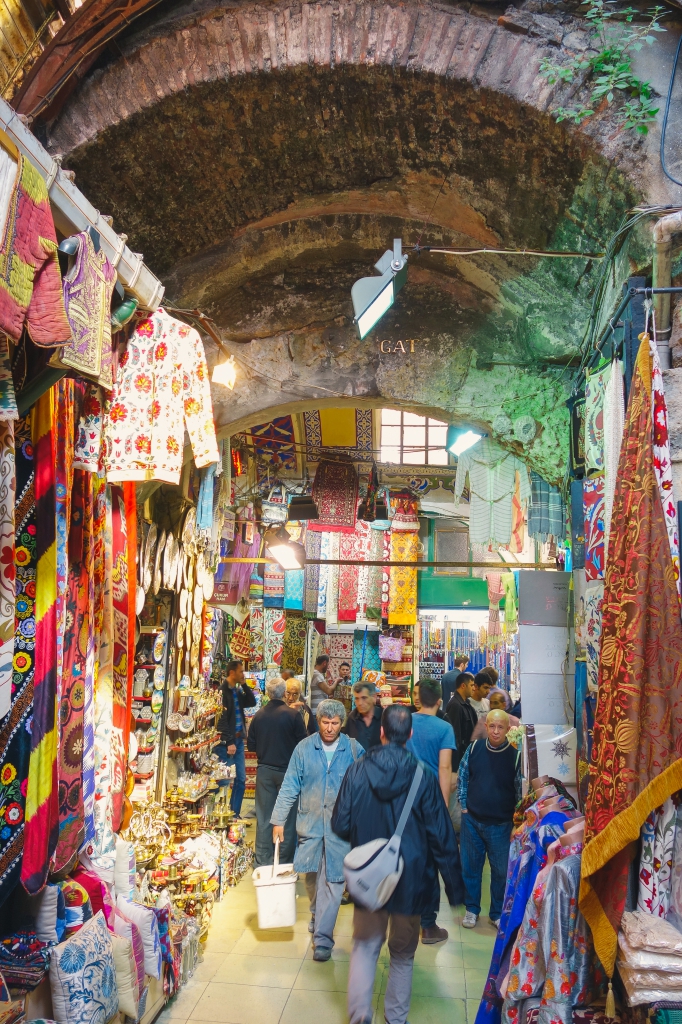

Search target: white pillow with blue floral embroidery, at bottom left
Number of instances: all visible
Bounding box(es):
[50,912,119,1024]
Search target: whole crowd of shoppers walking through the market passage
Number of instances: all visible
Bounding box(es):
[218,655,521,1024]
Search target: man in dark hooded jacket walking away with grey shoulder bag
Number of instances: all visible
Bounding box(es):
[332,705,464,1024]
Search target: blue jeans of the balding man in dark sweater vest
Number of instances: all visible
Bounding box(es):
[460,814,513,921]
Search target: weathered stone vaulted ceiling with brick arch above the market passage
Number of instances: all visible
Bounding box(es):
[37,0,647,479]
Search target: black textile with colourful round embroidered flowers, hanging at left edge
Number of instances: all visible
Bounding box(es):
[0,417,36,906]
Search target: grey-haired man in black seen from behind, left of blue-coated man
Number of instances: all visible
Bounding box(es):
[247,676,305,866]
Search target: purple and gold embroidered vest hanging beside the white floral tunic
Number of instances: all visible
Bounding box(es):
[50,231,116,391]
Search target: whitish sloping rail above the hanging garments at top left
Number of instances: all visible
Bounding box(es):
[0,98,164,310]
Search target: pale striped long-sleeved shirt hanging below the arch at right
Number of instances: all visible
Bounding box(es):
[455,437,530,546]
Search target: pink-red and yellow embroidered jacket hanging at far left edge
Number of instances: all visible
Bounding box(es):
[0,147,71,348]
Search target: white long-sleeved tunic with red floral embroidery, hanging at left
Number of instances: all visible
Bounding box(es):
[103,309,218,483]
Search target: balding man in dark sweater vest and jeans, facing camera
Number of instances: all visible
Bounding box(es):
[458,711,522,928]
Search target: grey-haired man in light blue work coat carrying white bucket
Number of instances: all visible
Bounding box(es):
[270,700,365,961]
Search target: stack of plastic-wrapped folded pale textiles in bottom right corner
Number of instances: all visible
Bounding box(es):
[619,910,682,1007]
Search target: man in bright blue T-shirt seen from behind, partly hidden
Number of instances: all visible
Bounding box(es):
[407,679,456,945]
